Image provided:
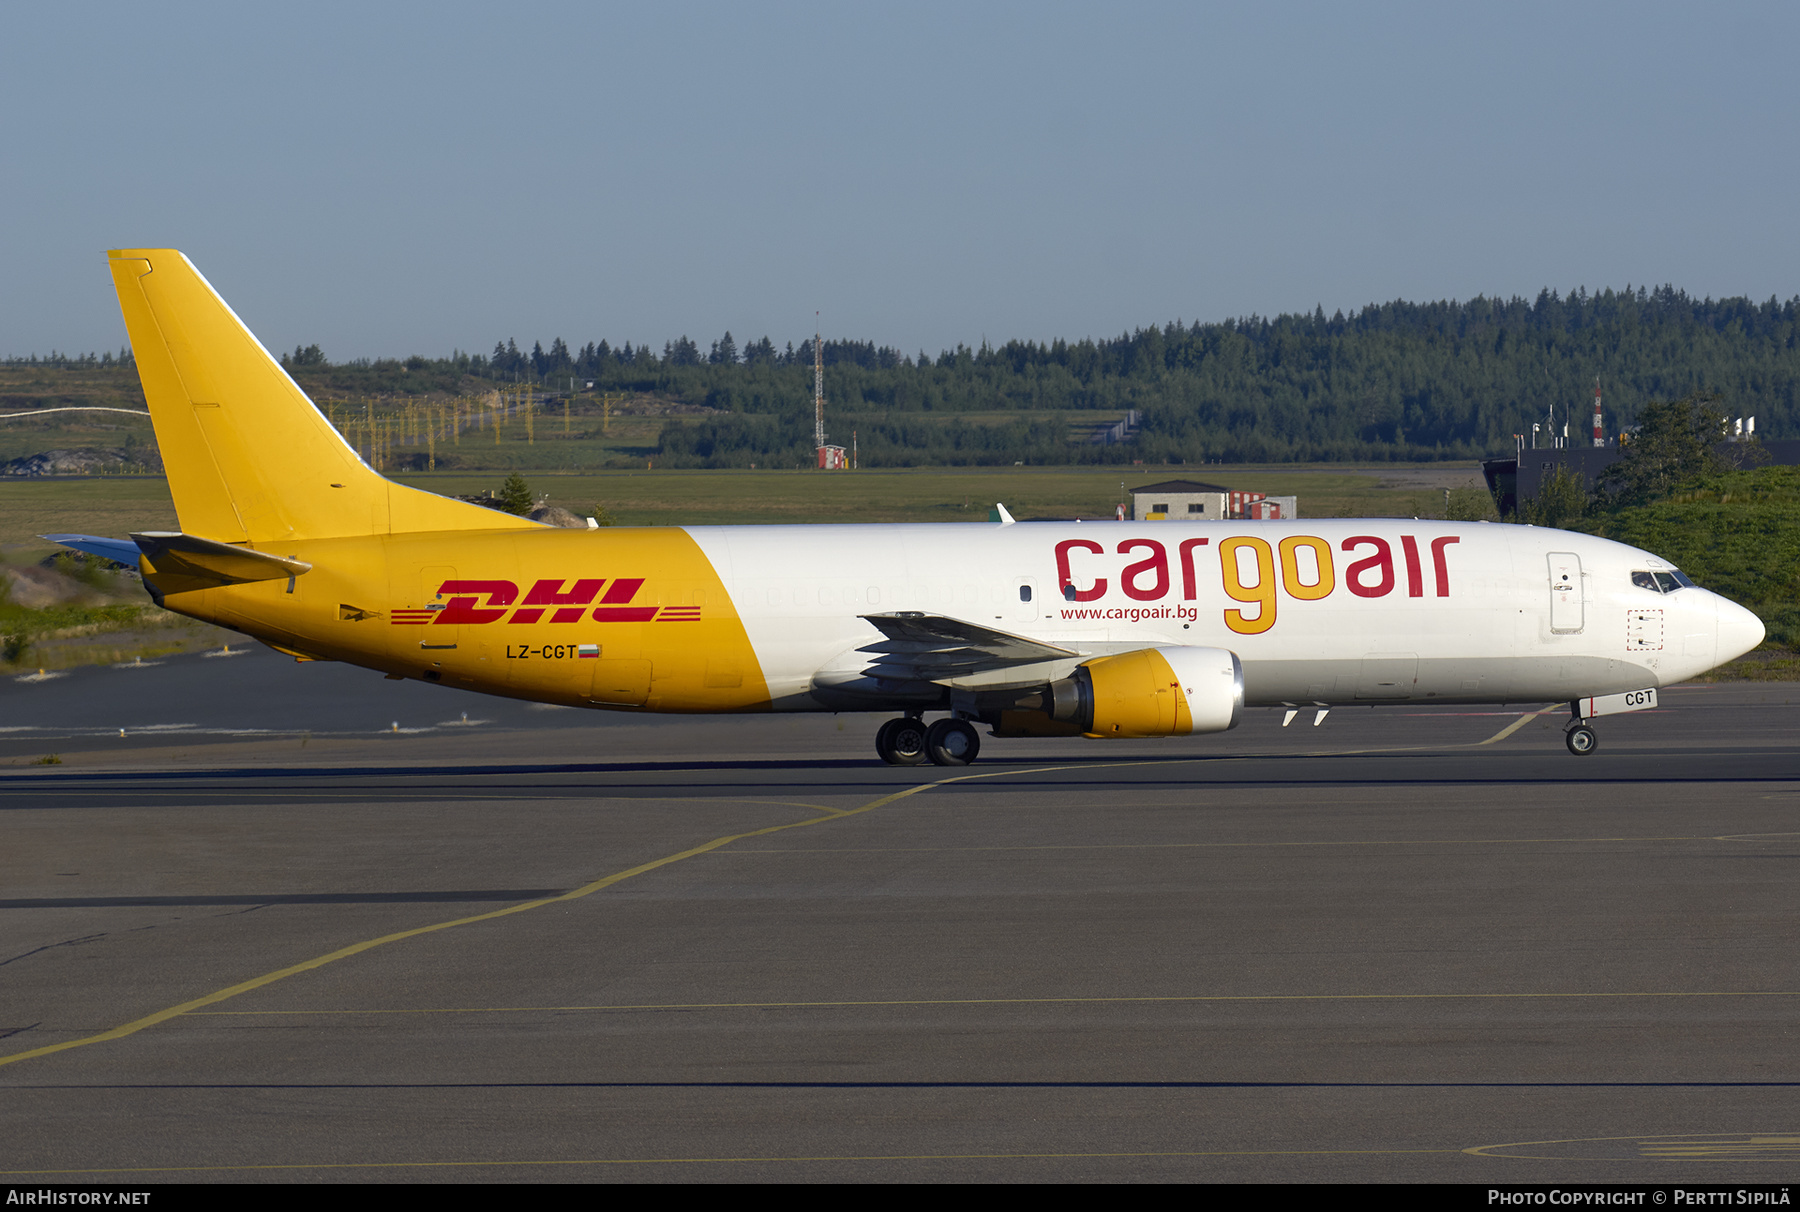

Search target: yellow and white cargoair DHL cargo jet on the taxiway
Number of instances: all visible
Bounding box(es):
[50,249,1762,765]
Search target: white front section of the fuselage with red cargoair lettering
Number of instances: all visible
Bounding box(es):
[688,519,1762,710]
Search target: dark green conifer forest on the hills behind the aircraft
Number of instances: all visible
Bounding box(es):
[14,286,1800,466]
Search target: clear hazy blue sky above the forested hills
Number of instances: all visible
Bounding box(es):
[0,4,1800,360]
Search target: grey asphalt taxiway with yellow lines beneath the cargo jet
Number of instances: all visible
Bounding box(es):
[0,648,1800,1185]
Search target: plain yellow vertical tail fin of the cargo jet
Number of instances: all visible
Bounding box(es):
[106,249,535,546]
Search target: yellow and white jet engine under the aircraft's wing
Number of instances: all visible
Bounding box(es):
[994,648,1244,737]
